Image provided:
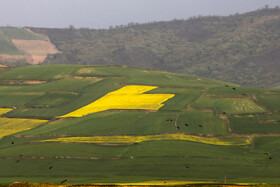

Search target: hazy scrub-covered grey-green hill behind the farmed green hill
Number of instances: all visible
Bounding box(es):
[27,8,280,87]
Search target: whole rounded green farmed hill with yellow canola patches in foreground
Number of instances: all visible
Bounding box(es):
[0,65,280,185]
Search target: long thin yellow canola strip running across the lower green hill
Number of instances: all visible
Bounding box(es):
[40,134,251,145]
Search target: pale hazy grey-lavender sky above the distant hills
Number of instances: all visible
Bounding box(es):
[0,0,280,28]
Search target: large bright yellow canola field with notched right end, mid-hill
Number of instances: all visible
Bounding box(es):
[61,85,174,117]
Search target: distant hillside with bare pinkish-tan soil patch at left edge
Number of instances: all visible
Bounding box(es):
[0,27,58,66]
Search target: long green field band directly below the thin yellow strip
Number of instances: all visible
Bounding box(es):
[0,140,252,160]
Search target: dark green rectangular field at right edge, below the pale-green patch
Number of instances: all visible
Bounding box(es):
[229,116,280,134]
